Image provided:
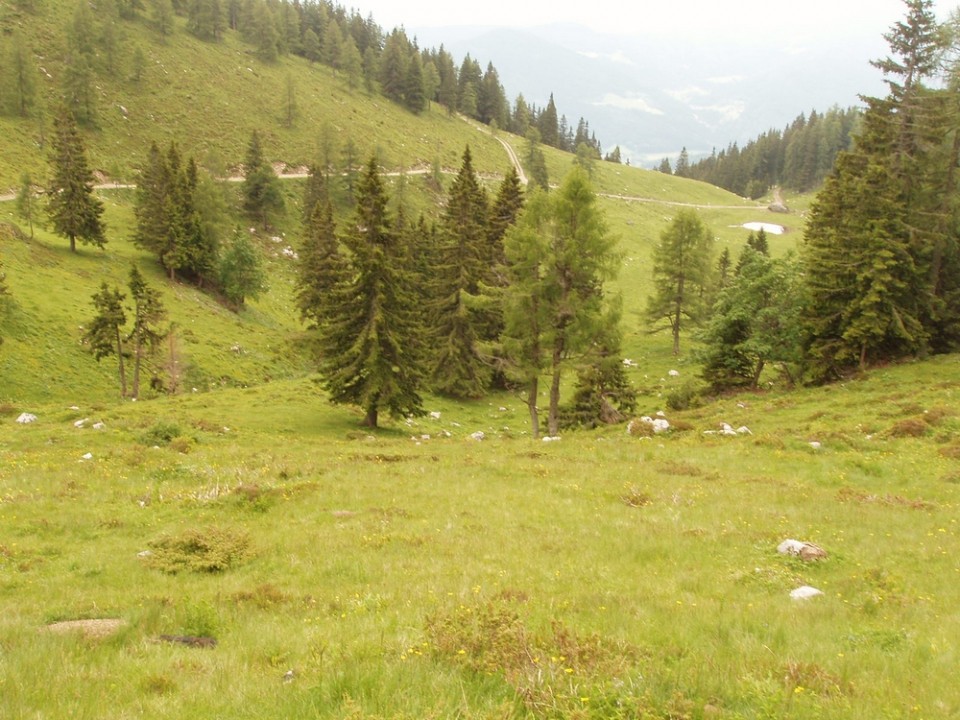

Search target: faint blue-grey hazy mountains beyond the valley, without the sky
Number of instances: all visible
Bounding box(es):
[409,25,885,166]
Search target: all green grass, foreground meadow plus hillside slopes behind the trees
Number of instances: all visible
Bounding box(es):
[0,8,960,720]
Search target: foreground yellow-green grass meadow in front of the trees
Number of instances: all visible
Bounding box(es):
[0,356,960,718]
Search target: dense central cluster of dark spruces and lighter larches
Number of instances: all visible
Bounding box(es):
[296,148,629,433]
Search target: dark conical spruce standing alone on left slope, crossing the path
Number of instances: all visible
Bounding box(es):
[47,110,107,252]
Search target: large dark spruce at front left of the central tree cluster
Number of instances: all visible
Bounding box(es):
[320,158,424,427]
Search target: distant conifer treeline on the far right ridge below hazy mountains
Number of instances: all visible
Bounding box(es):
[658,107,861,199]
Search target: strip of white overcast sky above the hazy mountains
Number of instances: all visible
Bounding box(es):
[343,0,957,42]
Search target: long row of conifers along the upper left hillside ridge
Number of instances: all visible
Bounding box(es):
[0,0,600,158]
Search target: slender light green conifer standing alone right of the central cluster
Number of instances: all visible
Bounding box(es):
[646,209,712,355]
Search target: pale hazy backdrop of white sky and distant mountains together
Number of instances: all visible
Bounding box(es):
[357,0,953,167]
